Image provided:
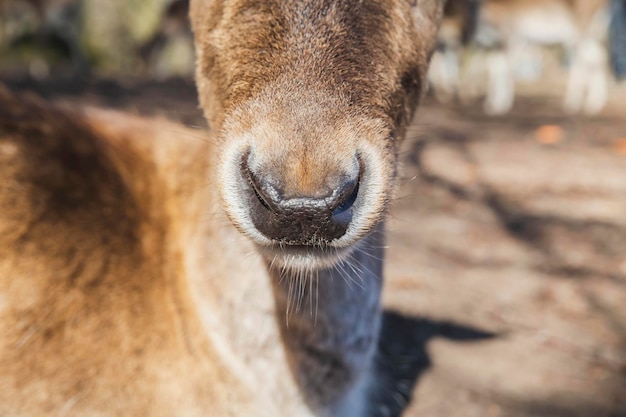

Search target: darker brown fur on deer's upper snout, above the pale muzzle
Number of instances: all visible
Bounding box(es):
[191,0,441,132]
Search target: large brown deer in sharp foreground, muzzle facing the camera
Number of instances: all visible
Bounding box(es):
[0,0,442,417]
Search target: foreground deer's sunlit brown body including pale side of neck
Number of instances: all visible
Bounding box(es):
[0,96,324,416]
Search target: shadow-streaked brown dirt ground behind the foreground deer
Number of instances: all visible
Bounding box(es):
[0,78,626,417]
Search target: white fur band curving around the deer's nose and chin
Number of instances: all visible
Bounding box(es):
[218,118,394,272]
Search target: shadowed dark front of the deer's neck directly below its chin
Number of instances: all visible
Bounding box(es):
[268,225,384,416]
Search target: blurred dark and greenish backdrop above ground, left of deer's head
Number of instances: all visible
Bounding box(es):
[0,0,193,79]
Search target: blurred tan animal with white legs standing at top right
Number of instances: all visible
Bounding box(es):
[473,0,609,115]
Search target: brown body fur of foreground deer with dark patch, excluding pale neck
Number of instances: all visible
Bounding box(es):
[0,87,258,416]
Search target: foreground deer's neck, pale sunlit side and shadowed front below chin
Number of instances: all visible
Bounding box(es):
[183,168,384,416]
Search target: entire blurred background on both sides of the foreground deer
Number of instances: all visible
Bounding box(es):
[0,0,626,417]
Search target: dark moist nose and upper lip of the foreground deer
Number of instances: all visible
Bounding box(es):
[242,158,359,245]
